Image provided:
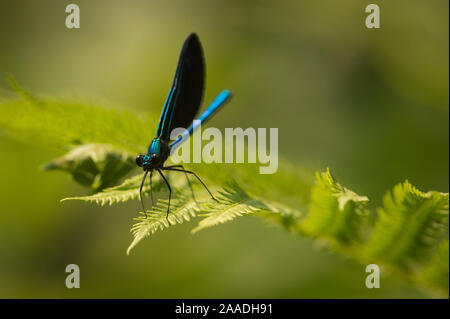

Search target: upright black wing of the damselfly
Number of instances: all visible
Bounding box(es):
[156,33,205,140]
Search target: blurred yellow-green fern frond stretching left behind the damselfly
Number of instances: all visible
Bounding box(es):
[0,89,155,154]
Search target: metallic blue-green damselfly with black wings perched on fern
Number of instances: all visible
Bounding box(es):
[136,33,231,218]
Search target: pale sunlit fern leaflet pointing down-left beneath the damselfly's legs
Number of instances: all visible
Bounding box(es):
[127,190,200,255]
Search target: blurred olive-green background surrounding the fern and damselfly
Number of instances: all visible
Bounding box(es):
[0,0,449,298]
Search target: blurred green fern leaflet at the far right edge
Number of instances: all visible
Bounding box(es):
[365,181,449,266]
